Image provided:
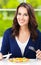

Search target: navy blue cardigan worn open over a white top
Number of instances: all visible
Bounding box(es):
[1,28,41,58]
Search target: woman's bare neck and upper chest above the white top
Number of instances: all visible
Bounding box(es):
[18,27,30,43]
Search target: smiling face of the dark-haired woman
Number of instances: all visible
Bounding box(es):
[17,7,29,26]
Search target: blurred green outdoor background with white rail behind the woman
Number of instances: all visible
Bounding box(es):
[0,0,41,38]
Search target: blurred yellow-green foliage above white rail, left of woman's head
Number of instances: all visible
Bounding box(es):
[0,0,20,8]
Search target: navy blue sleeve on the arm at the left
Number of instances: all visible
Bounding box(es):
[1,31,9,55]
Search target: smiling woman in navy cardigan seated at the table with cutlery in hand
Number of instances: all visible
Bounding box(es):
[0,3,41,59]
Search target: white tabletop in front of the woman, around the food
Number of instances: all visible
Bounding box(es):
[0,59,41,65]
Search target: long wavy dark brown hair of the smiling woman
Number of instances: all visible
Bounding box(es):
[12,2,38,40]
